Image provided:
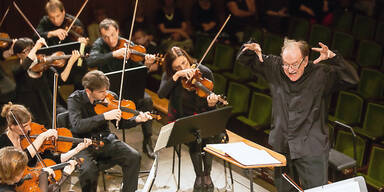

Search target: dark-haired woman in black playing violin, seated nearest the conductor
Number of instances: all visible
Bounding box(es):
[157,47,219,191]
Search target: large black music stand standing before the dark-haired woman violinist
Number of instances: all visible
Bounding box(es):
[154,106,232,189]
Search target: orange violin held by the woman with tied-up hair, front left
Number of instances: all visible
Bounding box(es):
[20,122,104,153]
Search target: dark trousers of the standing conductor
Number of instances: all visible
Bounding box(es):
[275,153,328,192]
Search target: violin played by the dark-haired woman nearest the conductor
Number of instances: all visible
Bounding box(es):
[181,66,228,105]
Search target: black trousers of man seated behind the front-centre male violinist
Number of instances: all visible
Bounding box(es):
[136,93,153,141]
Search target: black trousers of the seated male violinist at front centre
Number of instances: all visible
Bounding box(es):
[77,139,141,192]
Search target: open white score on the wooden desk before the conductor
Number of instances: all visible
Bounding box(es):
[207,142,281,166]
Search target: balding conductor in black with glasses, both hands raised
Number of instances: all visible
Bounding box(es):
[237,39,359,191]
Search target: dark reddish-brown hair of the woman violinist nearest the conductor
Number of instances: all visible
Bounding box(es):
[163,47,196,77]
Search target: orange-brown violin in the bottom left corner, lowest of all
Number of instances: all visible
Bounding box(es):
[16,158,84,192]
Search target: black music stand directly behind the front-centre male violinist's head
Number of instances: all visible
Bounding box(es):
[105,66,147,142]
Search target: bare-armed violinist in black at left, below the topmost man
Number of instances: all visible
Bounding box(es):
[13,38,80,127]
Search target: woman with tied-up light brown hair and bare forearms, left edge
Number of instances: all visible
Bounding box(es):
[0,103,92,166]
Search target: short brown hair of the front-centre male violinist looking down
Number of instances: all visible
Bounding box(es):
[82,70,110,91]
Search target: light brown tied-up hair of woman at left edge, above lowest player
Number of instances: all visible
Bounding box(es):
[1,102,32,129]
